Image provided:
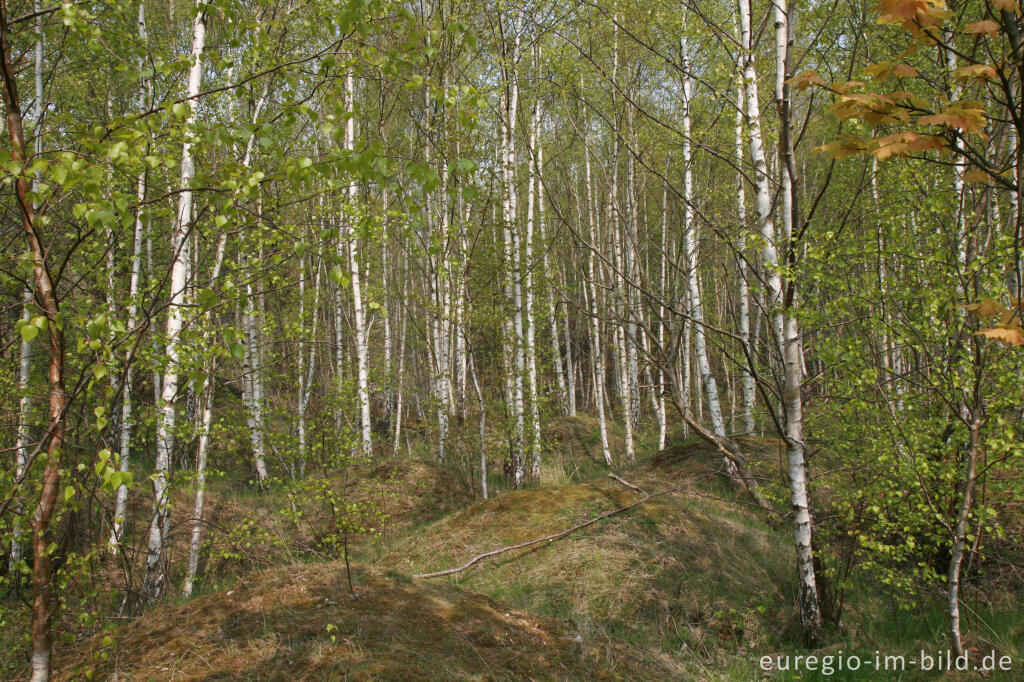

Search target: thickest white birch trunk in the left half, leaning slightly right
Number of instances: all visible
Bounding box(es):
[143,2,206,600]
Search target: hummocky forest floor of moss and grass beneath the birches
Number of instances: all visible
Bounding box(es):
[44,418,1024,680]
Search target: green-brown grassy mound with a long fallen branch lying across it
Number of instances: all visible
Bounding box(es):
[377,454,794,677]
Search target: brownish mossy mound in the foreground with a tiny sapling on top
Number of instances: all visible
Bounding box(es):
[57,562,679,680]
